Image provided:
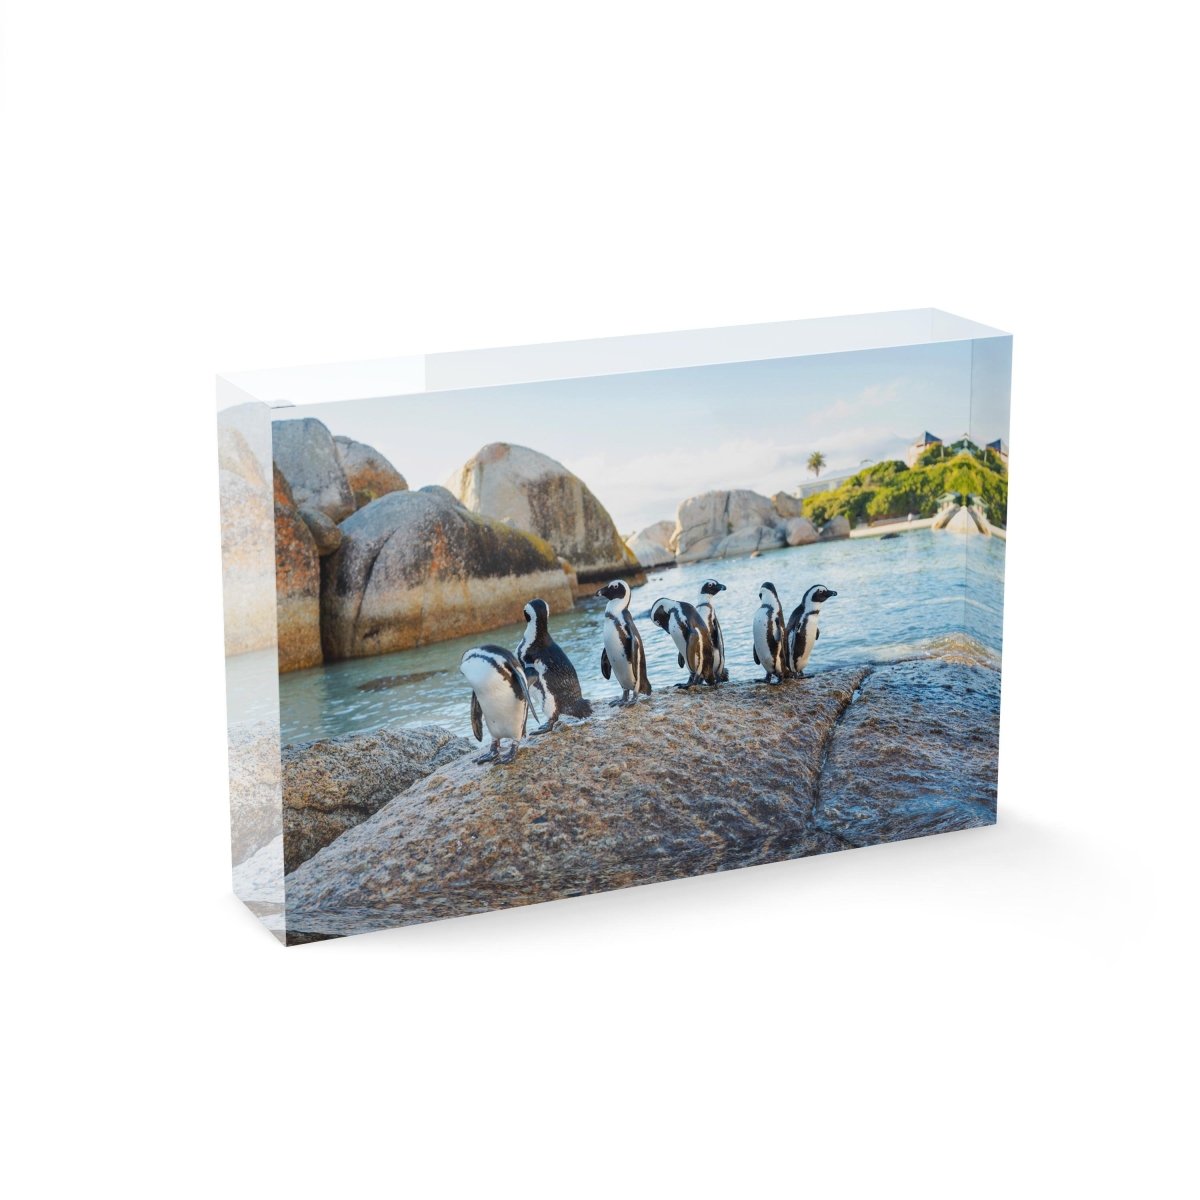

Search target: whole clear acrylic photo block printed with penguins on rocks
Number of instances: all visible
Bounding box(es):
[217,308,1012,944]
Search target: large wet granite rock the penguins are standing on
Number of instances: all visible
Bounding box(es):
[287,662,998,940]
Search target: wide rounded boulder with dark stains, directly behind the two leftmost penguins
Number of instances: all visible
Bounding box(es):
[320,492,572,659]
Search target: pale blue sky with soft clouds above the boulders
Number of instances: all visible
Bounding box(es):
[272,337,1010,534]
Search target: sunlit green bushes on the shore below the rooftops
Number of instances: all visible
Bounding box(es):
[804,445,1008,527]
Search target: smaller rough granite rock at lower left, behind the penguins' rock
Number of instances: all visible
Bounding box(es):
[282,725,478,871]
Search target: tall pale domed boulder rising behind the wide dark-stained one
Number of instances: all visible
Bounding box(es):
[446,442,644,584]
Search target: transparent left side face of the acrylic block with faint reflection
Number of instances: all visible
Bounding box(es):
[217,386,283,940]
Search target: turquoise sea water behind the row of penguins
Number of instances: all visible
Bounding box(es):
[272,530,1004,743]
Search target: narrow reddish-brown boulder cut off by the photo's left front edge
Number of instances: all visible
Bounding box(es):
[275,467,322,672]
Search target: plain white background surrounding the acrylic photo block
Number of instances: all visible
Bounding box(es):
[0,0,1200,1198]
